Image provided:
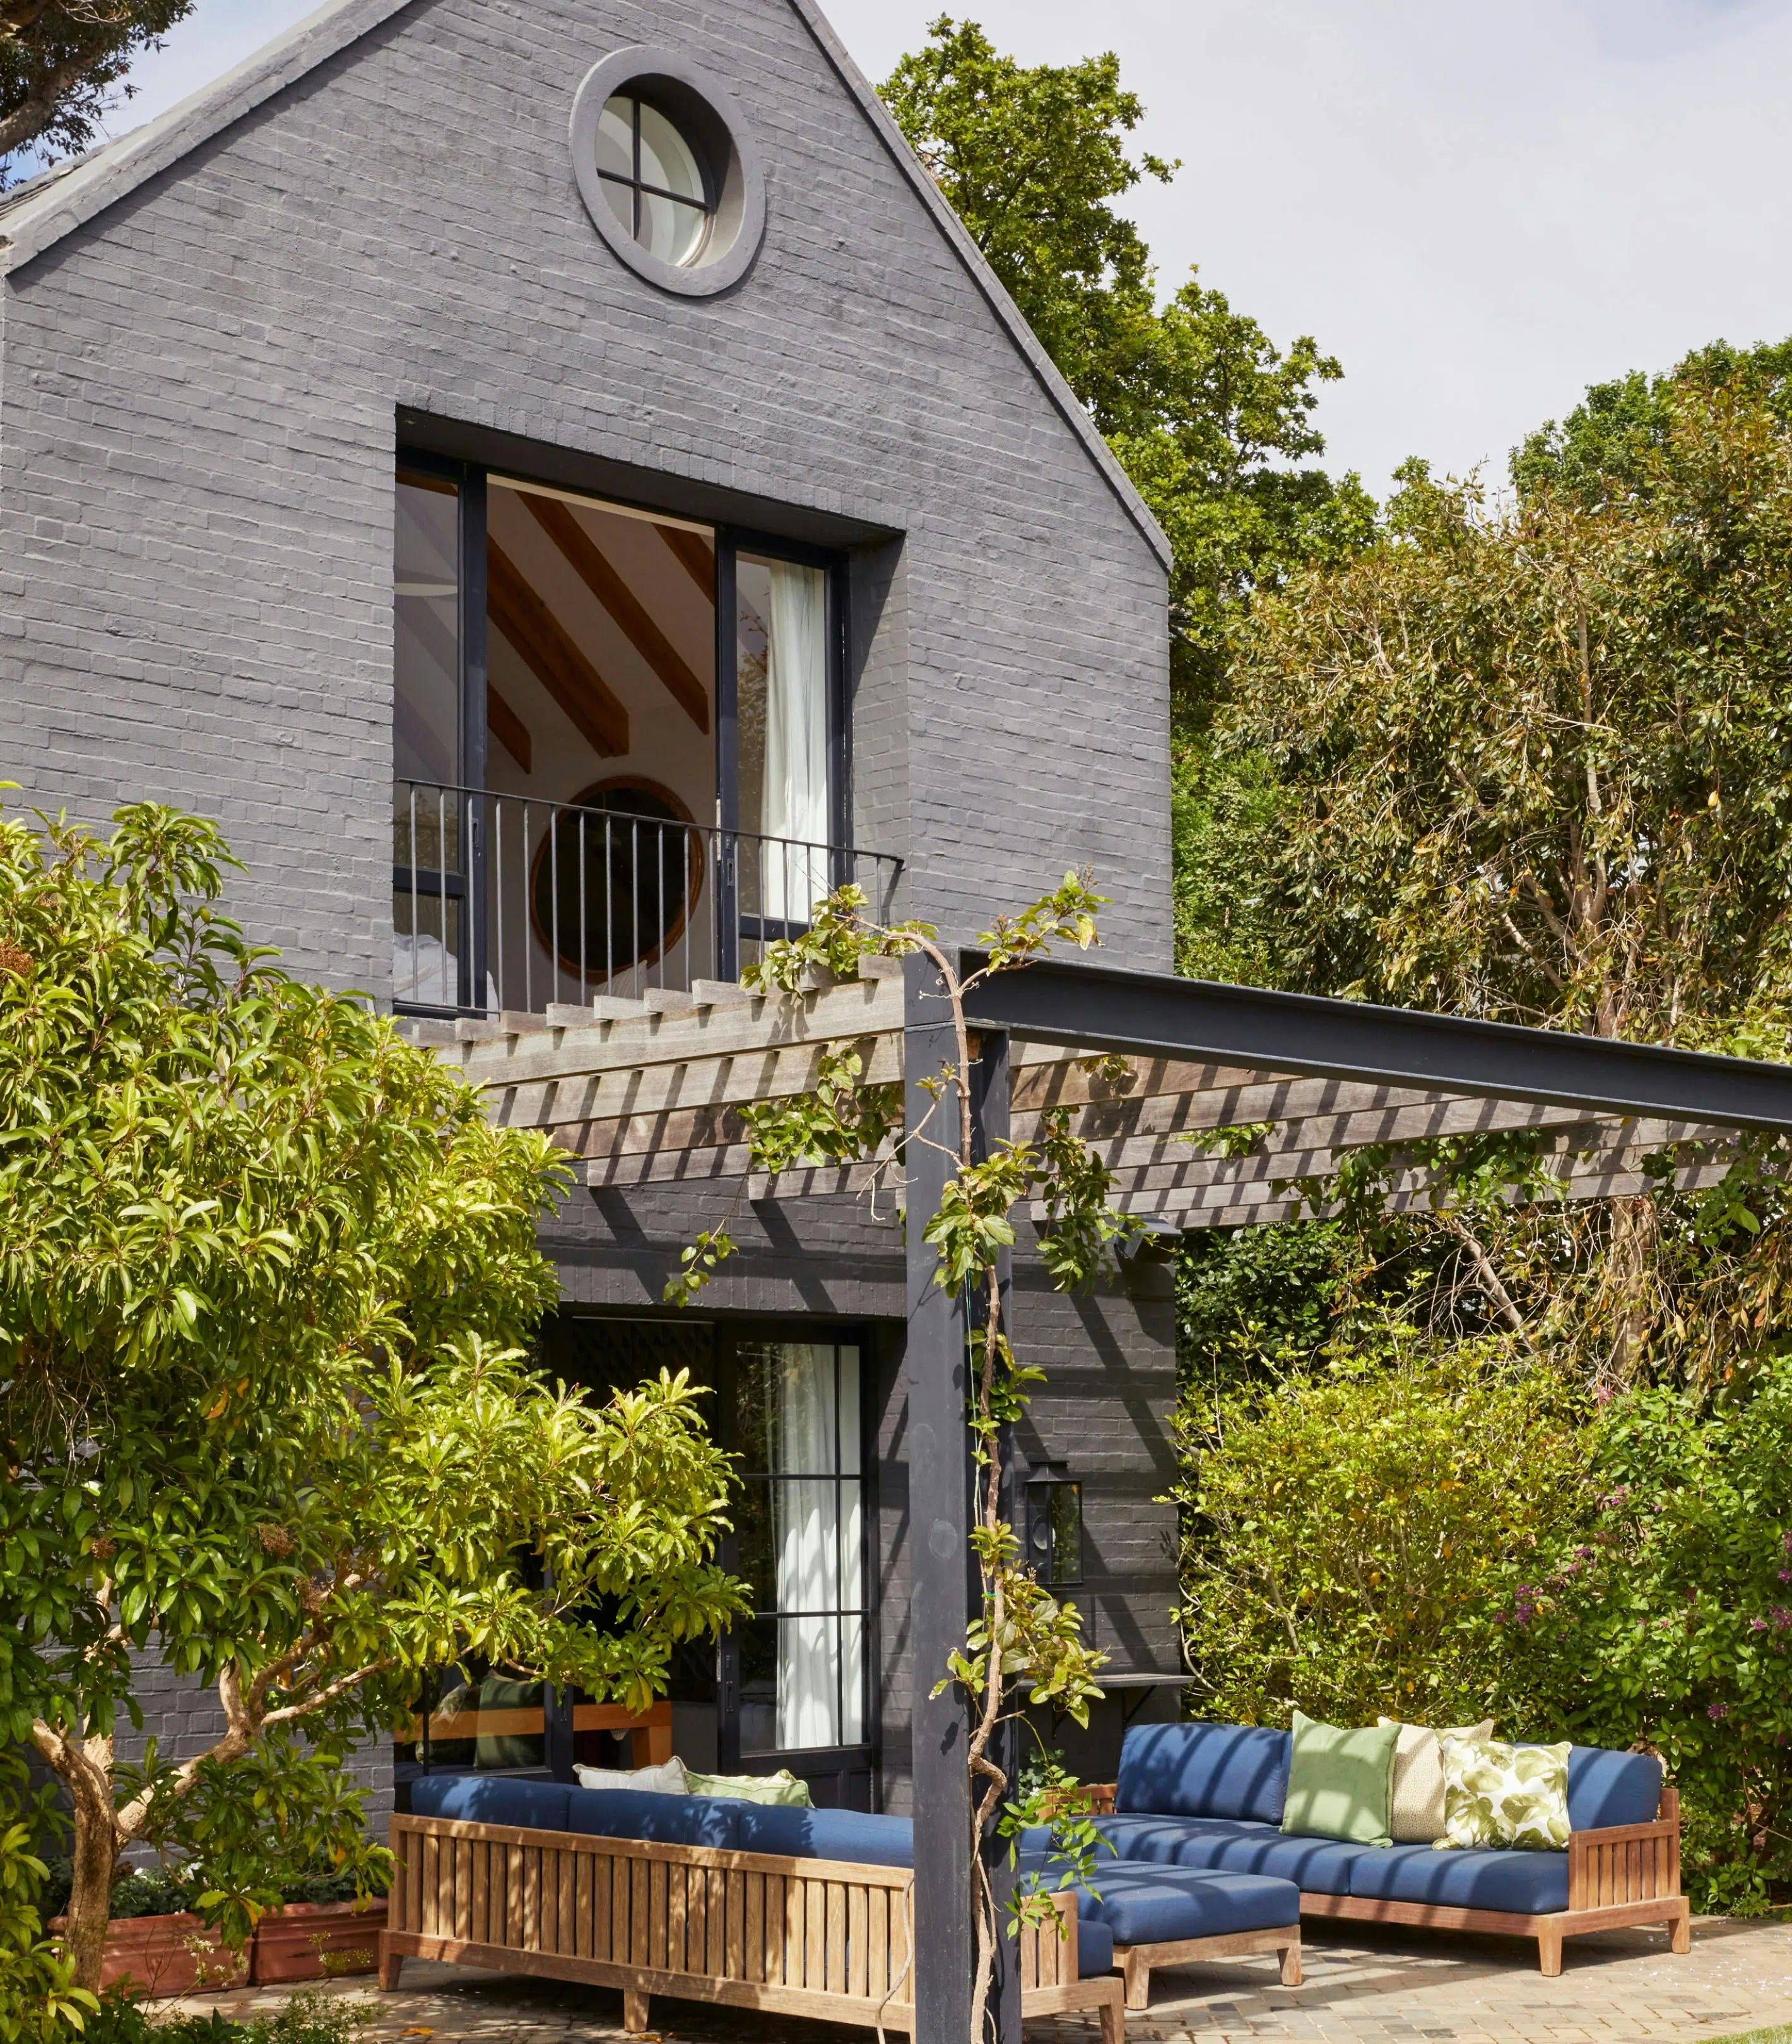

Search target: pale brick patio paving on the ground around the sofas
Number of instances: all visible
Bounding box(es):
[157,1917,1792,2044]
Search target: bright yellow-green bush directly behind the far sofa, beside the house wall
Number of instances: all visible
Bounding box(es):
[1177,1327,1592,1725]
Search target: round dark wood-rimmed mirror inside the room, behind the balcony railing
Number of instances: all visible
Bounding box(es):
[529,778,705,985]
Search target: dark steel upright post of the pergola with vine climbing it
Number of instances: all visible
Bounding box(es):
[903,956,972,2044]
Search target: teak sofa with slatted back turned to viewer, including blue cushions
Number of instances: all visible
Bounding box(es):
[380,1774,1124,2044]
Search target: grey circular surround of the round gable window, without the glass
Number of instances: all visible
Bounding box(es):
[570,43,766,298]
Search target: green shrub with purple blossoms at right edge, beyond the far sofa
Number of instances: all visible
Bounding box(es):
[1502,1355,1792,1911]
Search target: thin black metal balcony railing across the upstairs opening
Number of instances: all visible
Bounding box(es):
[392,781,901,1016]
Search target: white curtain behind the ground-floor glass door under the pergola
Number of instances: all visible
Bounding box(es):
[772,1341,864,1752]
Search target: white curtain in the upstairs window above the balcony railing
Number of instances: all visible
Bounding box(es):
[760,560,830,922]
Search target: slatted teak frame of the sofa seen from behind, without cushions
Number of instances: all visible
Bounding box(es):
[380,1817,1124,2044]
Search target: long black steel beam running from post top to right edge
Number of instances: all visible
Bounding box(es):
[960,951,1792,1131]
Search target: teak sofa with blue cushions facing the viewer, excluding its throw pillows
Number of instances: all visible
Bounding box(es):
[1062,1723,1692,1975]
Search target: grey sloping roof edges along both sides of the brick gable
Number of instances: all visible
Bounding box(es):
[0,0,1171,566]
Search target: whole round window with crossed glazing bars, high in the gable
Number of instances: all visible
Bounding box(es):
[572,49,764,295]
